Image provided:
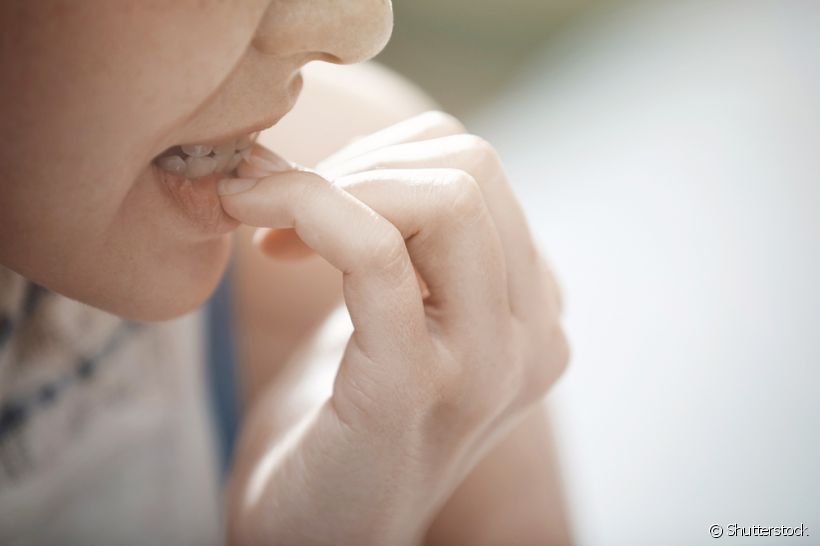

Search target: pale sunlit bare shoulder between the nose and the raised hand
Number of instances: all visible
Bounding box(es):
[260,62,436,166]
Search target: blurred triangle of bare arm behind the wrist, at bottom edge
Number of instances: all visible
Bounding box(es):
[426,400,572,546]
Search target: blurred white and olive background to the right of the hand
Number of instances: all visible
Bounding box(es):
[380,0,820,545]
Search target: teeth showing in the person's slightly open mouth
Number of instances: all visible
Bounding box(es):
[156,134,256,179]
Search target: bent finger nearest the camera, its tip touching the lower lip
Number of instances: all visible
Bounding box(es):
[221,170,429,363]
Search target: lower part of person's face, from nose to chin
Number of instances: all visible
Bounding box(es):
[0,0,392,320]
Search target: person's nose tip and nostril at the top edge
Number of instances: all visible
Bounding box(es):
[251,0,393,64]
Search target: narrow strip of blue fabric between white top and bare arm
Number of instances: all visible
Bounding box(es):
[206,268,240,476]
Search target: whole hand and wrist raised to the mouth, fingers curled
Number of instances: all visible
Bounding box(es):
[222,113,568,544]
